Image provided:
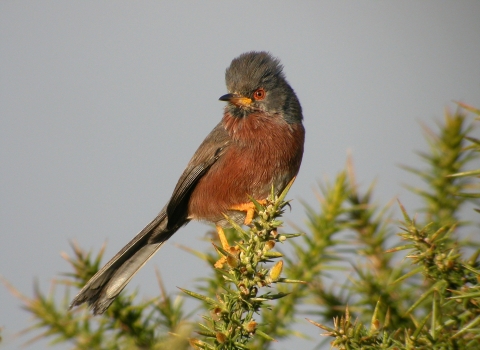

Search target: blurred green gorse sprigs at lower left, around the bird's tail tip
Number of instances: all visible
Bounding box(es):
[2,244,191,349]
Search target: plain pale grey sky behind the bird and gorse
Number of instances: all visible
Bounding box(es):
[0,0,480,349]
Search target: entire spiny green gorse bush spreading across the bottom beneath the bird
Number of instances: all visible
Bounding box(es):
[6,104,480,349]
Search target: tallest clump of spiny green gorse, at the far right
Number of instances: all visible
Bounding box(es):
[311,105,480,349]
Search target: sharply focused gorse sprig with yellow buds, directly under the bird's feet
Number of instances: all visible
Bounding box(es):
[183,182,303,350]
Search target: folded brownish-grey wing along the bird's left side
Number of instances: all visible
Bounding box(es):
[163,123,231,228]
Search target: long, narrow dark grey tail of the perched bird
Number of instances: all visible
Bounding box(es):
[70,208,178,315]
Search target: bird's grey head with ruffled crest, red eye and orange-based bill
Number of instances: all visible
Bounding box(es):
[220,51,303,123]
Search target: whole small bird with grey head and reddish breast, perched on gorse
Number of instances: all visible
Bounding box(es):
[70,52,305,314]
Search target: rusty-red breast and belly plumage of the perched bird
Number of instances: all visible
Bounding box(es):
[188,113,305,222]
